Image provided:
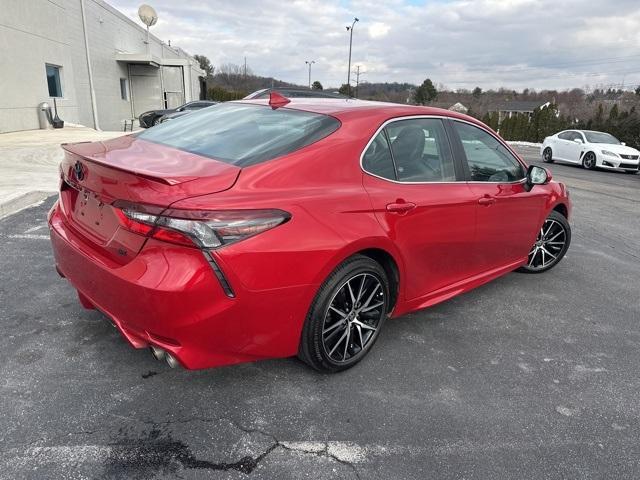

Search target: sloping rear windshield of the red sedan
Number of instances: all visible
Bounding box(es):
[138,103,340,167]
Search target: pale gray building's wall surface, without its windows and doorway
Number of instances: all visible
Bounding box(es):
[0,0,202,132]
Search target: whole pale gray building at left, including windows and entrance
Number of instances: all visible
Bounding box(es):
[0,0,204,132]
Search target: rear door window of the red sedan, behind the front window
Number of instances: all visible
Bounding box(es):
[385,118,456,182]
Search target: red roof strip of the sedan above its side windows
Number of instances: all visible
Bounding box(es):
[233,98,482,125]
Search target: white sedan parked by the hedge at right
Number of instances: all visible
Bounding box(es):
[540,130,640,173]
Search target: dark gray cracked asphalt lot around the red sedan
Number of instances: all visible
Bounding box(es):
[0,148,640,479]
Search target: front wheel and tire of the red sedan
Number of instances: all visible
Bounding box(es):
[518,210,571,273]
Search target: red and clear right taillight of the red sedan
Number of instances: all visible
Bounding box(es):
[114,203,291,248]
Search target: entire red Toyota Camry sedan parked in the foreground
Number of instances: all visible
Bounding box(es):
[49,93,571,372]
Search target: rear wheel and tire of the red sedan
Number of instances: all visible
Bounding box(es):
[298,255,390,372]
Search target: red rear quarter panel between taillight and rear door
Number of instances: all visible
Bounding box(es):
[172,113,397,290]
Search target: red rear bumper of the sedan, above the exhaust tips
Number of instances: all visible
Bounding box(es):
[49,202,309,369]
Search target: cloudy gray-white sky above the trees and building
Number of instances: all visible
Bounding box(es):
[107,0,640,90]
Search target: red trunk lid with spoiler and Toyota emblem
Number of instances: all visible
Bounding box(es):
[60,135,241,264]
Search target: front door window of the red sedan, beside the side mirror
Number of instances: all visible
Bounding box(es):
[453,121,525,183]
